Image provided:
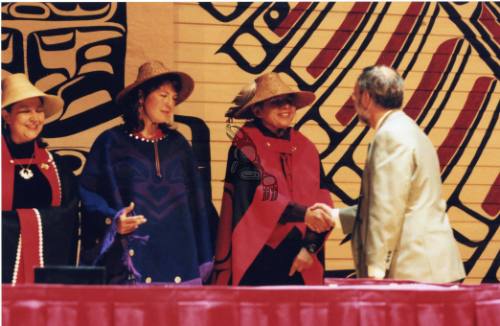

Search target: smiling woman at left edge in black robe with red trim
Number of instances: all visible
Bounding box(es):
[2,74,78,284]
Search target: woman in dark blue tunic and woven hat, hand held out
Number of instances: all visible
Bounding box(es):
[80,61,213,284]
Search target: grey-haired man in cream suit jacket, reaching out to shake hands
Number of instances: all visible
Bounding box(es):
[316,66,465,282]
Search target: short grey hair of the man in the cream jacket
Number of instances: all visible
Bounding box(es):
[358,65,404,109]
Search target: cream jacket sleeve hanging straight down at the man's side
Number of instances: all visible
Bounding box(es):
[365,130,414,276]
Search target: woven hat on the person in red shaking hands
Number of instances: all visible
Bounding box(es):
[226,72,316,119]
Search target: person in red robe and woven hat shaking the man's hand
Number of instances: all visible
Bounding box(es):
[213,73,332,285]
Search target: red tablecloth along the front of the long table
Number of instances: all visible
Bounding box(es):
[2,280,500,326]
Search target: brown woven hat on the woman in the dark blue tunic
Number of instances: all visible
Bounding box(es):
[116,60,194,104]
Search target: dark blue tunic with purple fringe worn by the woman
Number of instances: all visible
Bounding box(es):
[80,126,213,284]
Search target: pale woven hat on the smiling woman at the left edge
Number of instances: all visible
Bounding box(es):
[2,74,64,118]
